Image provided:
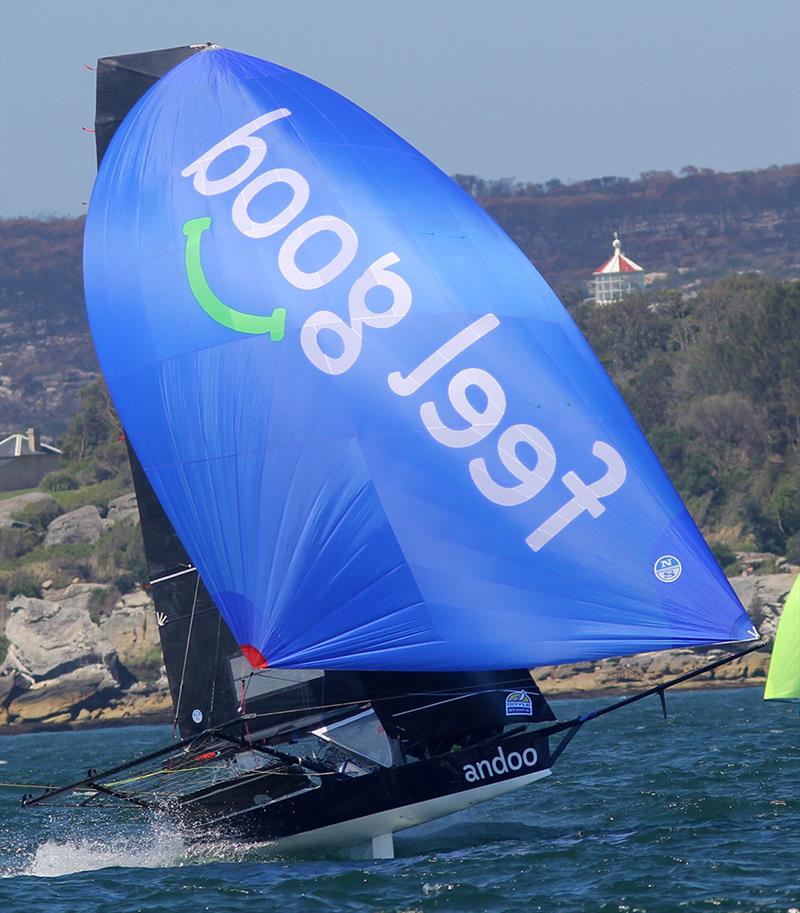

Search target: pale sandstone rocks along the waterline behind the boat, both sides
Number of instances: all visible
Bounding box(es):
[0,560,796,734]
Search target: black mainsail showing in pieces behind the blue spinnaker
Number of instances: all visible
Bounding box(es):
[95,45,365,737]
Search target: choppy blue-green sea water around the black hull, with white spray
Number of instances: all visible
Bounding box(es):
[0,688,800,913]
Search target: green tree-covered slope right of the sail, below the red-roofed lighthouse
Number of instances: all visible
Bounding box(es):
[572,274,800,552]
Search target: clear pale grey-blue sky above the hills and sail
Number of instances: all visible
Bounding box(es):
[0,0,800,215]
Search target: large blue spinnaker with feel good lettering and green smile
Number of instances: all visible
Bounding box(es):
[84,49,755,670]
